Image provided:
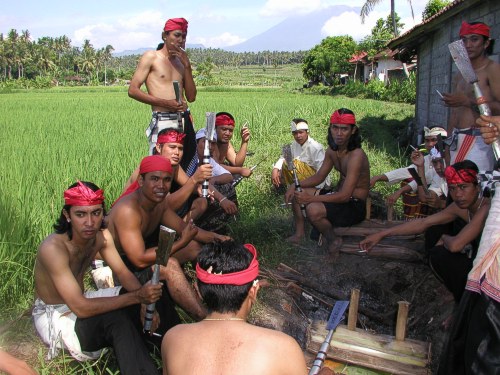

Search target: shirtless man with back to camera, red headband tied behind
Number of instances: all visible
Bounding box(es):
[162,241,307,375]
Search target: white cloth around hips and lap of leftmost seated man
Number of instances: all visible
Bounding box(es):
[32,286,121,361]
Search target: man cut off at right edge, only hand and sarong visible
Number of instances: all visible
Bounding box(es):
[438,116,500,375]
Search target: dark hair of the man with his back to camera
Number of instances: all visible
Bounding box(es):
[198,240,253,313]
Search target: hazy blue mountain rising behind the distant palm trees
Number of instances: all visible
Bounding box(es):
[224,5,361,52]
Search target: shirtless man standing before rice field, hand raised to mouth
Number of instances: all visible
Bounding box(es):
[128,18,196,168]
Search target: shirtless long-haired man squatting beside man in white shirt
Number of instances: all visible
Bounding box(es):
[285,108,370,260]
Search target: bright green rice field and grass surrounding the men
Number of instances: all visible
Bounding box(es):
[0,87,414,373]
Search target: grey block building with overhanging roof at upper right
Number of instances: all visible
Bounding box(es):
[388,0,500,142]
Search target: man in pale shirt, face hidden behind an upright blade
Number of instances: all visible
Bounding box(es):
[186,128,242,233]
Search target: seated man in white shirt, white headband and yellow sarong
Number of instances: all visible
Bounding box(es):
[271,118,330,243]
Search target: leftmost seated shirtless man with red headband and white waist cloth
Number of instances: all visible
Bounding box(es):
[32,181,162,375]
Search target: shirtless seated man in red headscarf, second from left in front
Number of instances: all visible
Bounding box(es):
[106,155,228,327]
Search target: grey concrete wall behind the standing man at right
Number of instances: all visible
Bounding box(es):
[415,0,500,141]
